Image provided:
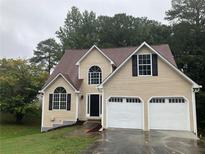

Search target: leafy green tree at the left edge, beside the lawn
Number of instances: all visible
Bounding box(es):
[0,59,48,122]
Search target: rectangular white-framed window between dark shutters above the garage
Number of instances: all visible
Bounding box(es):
[138,54,152,75]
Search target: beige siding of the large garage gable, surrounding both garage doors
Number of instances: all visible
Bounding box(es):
[103,48,193,130]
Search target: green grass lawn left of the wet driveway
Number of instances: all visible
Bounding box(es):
[0,112,96,154]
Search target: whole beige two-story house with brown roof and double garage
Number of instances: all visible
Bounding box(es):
[41,42,201,133]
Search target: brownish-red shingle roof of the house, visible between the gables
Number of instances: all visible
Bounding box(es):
[44,44,176,90]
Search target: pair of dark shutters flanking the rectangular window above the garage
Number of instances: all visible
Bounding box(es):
[132,54,158,76]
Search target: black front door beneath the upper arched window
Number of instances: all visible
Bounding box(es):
[90,94,99,117]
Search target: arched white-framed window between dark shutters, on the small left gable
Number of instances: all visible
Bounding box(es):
[52,87,67,109]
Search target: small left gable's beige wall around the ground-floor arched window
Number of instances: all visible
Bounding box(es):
[42,75,77,127]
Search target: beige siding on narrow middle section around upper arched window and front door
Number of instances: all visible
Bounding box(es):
[78,48,112,120]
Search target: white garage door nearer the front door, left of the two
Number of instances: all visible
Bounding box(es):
[107,97,143,129]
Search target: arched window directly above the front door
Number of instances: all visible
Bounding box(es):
[88,66,102,84]
